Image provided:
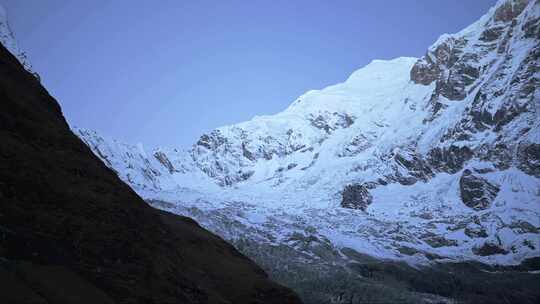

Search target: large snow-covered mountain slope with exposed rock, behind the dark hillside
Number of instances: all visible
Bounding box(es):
[74,0,540,264]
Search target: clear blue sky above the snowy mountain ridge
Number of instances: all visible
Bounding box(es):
[0,0,495,147]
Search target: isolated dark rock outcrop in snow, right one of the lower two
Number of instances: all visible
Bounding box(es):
[459,169,500,210]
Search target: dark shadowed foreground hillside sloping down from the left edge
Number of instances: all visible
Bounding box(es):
[0,45,300,304]
